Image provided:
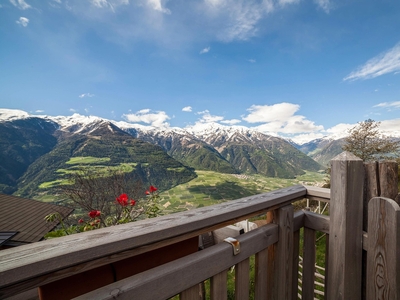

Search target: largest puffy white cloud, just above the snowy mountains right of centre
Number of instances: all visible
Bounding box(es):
[242,102,324,134]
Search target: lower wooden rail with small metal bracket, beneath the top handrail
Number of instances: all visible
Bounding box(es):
[75,224,278,300]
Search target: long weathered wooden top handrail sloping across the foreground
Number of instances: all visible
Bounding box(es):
[0,185,307,298]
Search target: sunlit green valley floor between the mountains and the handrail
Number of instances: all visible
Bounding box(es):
[160,171,325,214]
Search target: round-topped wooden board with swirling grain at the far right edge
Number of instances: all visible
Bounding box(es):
[367,197,400,300]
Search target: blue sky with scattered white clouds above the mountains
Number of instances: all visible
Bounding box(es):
[0,0,400,142]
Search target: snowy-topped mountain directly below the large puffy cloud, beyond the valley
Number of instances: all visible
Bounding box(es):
[187,124,322,178]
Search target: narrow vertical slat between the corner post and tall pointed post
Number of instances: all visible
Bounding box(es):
[302,227,316,299]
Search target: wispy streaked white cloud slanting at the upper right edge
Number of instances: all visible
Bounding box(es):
[343,43,400,80]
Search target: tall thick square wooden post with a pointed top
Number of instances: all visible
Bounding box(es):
[327,152,364,300]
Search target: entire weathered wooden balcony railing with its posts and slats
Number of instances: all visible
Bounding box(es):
[0,153,400,300]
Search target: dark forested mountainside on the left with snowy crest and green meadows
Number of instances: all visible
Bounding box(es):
[0,112,196,197]
